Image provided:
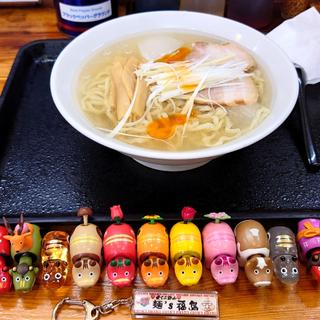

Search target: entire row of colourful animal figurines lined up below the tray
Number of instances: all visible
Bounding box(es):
[0,206,320,293]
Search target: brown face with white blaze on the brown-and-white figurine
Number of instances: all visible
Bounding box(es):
[244,257,273,287]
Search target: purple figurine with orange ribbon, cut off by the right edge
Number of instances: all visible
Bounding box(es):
[297,219,320,282]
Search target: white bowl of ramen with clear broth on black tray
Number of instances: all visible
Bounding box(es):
[50,11,298,171]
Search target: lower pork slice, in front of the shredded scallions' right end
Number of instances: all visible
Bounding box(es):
[195,77,259,107]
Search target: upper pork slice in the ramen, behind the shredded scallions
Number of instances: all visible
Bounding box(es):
[187,41,256,71]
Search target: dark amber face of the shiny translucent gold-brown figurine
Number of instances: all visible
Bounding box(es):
[40,260,68,289]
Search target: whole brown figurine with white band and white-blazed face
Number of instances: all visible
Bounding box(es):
[234,220,273,287]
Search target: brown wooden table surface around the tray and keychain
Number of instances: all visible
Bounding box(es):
[0,1,320,320]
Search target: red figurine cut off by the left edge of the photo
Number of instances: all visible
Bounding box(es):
[0,226,12,294]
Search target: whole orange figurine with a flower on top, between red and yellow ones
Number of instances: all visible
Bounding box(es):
[138,215,169,288]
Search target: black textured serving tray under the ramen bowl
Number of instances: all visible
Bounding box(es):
[0,40,320,223]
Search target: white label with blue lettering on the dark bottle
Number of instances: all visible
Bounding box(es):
[59,0,112,22]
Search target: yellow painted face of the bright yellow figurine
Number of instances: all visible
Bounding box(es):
[174,256,202,286]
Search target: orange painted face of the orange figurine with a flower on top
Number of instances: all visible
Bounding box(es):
[141,257,169,288]
